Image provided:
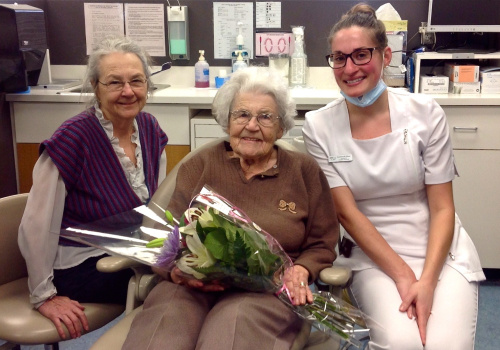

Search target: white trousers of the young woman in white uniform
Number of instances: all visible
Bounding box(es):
[350,264,479,350]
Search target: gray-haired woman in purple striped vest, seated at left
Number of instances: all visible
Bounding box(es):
[19,38,168,339]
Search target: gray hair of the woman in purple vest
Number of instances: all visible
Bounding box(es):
[82,36,154,106]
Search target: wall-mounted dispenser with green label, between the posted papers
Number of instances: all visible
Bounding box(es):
[167,6,189,60]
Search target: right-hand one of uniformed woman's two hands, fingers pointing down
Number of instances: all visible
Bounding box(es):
[399,281,434,345]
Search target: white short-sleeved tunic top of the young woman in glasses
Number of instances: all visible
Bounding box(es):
[303,88,484,280]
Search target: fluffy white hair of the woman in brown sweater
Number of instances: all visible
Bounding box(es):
[212,67,297,133]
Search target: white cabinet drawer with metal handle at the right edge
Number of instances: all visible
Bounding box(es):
[443,106,500,149]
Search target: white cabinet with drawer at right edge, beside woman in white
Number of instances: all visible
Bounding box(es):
[443,106,500,269]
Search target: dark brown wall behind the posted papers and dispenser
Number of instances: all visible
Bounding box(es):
[0,0,429,67]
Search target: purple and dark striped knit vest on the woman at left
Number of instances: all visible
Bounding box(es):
[39,108,168,245]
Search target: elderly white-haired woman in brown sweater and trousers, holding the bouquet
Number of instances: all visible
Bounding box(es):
[124,67,339,350]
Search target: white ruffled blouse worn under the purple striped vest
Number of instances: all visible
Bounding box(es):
[18,107,167,307]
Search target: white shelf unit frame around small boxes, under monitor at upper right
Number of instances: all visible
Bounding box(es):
[414,52,500,93]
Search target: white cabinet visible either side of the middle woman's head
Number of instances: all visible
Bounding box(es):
[191,110,304,150]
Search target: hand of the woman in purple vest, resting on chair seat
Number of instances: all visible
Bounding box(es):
[38,296,89,339]
